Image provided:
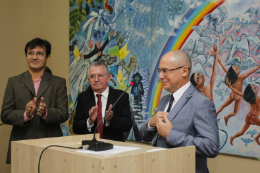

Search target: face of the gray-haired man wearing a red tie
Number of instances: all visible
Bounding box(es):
[88,65,111,93]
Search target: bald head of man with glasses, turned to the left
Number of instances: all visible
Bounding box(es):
[159,50,191,93]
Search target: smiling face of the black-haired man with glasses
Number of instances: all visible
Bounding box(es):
[25,46,50,71]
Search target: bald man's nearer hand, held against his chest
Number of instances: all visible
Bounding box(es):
[156,115,173,138]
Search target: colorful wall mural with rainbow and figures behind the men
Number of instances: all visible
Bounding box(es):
[69,0,260,158]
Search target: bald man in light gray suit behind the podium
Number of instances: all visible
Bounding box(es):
[141,50,219,173]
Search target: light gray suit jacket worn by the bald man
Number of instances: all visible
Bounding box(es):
[140,85,219,173]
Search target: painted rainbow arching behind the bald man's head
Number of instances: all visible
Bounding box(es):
[146,0,225,118]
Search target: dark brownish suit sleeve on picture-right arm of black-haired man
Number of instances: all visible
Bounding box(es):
[44,79,69,124]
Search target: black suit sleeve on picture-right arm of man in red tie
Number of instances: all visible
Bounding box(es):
[109,93,132,132]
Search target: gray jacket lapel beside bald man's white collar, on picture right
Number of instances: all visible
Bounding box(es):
[168,84,195,121]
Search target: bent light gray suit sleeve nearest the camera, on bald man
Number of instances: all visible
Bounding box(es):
[166,99,219,158]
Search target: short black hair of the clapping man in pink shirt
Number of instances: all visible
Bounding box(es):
[24,38,51,58]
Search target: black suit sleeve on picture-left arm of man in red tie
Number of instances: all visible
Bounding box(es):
[73,95,90,134]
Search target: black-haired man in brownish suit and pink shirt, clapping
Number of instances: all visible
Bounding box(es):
[1,38,69,164]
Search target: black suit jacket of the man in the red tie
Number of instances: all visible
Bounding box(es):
[73,87,132,141]
